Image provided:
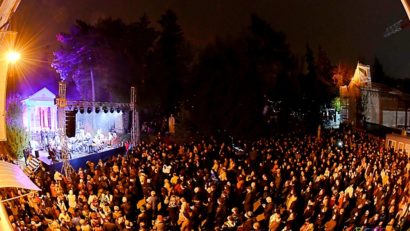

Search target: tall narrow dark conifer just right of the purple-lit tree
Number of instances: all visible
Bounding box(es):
[148,10,192,114]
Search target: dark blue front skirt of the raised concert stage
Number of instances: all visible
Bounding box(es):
[38,147,125,172]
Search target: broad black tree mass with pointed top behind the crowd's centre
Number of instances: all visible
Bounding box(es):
[192,15,298,137]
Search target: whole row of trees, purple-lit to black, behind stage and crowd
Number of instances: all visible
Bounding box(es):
[53,10,336,139]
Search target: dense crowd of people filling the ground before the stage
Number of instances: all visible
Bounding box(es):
[1,127,410,231]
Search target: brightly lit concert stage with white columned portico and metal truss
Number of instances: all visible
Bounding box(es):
[22,85,135,174]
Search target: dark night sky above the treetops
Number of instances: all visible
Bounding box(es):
[13,0,410,78]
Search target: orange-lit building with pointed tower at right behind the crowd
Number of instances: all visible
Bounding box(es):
[339,63,410,129]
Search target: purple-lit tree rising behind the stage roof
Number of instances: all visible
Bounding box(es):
[52,17,156,101]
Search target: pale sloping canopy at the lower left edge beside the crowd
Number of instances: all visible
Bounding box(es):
[0,161,41,191]
